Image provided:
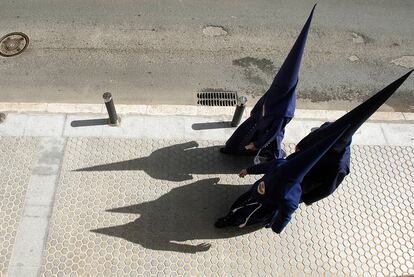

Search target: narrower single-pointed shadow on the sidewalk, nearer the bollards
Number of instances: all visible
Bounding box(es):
[75,141,252,182]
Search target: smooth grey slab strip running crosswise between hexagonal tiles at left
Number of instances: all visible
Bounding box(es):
[8,137,65,277]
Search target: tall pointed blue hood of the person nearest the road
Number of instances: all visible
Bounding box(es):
[263,4,316,117]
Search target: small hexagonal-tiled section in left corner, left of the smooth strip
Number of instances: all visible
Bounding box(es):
[0,137,39,276]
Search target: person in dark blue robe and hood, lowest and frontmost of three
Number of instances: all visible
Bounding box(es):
[215,126,348,234]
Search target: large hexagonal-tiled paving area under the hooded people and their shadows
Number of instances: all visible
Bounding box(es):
[41,138,414,276]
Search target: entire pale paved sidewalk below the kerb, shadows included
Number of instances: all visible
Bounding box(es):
[0,109,414,276]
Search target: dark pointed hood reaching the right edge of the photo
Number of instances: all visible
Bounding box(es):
[298,70,413,152]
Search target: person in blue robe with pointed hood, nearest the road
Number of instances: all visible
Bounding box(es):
[220,5,316,158]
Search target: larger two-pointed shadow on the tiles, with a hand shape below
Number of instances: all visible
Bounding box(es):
[91,178,262,253]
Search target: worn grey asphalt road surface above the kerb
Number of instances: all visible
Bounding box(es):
[0,0,414,111]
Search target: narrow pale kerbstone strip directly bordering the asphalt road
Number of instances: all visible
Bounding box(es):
[0,102,414,121]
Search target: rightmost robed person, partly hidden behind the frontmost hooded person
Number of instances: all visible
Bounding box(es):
[287,71,412,205]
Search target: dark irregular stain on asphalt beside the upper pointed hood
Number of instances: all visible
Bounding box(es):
[233,57,276,88]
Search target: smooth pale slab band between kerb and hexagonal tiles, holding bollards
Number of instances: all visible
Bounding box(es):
[0,113,414,146]
